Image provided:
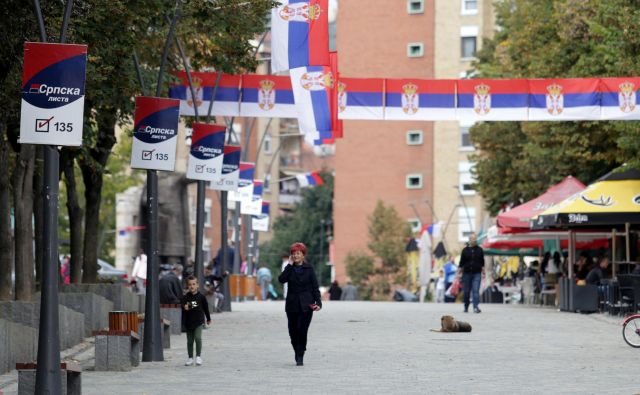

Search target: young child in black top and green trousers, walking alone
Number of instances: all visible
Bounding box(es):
[181,276,211,366]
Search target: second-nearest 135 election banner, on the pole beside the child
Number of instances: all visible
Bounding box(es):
[131,96,180,171]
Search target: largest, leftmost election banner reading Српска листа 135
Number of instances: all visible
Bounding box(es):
[19,42,87,146]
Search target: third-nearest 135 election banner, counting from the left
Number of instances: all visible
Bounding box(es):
[187,123,226,181]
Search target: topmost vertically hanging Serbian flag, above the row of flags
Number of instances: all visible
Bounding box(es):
[271,0,329,73]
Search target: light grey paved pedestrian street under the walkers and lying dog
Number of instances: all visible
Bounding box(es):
[5,302,640,395]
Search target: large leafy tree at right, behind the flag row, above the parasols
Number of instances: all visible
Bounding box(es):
[464,0,640,214]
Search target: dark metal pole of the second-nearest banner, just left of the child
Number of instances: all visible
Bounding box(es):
[142,3,180,362]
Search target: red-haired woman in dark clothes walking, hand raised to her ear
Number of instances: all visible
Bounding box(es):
[278,243,322,366]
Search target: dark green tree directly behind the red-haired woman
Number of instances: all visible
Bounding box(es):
[260,173,333,290]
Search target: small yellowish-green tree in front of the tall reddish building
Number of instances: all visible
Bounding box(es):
[367,200,411,274]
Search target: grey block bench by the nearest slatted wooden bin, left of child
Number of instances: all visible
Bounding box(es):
[92,330,141,372]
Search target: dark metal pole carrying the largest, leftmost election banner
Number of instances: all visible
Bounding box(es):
[33,0,67,395]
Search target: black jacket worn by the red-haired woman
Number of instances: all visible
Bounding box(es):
[278,262,322,313]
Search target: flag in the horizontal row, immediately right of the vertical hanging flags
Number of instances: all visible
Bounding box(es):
[337,78,384,121]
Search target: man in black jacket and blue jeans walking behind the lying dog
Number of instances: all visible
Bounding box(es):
[458,233,484,313]
